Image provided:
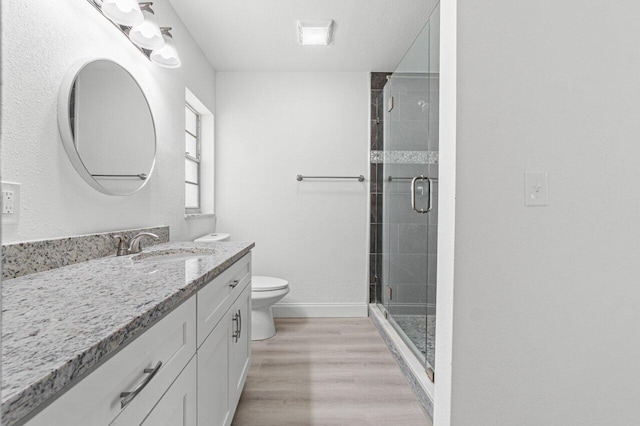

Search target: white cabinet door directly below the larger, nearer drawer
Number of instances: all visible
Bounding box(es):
[142,357,196,426]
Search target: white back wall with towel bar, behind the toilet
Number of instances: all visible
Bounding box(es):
[216,72,369,316]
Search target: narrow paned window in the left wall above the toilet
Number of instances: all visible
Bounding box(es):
[184,103,201,214]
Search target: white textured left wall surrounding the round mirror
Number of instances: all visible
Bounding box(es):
[1,0,215,243]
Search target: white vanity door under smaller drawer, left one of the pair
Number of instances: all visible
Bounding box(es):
[198,315,232,426]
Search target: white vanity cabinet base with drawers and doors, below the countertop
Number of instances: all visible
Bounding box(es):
[26,253,251,426]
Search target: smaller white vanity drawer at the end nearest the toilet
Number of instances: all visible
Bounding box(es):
[197,253,251,347]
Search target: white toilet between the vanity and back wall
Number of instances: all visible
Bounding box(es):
[194,232,289,340]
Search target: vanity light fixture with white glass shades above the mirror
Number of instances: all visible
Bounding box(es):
[87,0,182,68]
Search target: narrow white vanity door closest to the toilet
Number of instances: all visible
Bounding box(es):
[229,285,251,413]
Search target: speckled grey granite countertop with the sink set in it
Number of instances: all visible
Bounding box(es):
[2,242,254,425]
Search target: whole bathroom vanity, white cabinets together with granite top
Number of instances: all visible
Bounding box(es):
[2,243,253,426]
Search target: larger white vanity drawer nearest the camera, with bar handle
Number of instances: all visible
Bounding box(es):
[27,297,196,426]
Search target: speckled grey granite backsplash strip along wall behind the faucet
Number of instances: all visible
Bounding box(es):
[2,226,169,280]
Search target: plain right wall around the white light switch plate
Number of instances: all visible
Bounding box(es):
[448,0,640,426]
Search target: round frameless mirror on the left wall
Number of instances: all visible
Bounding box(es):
[58,59,156,195]
